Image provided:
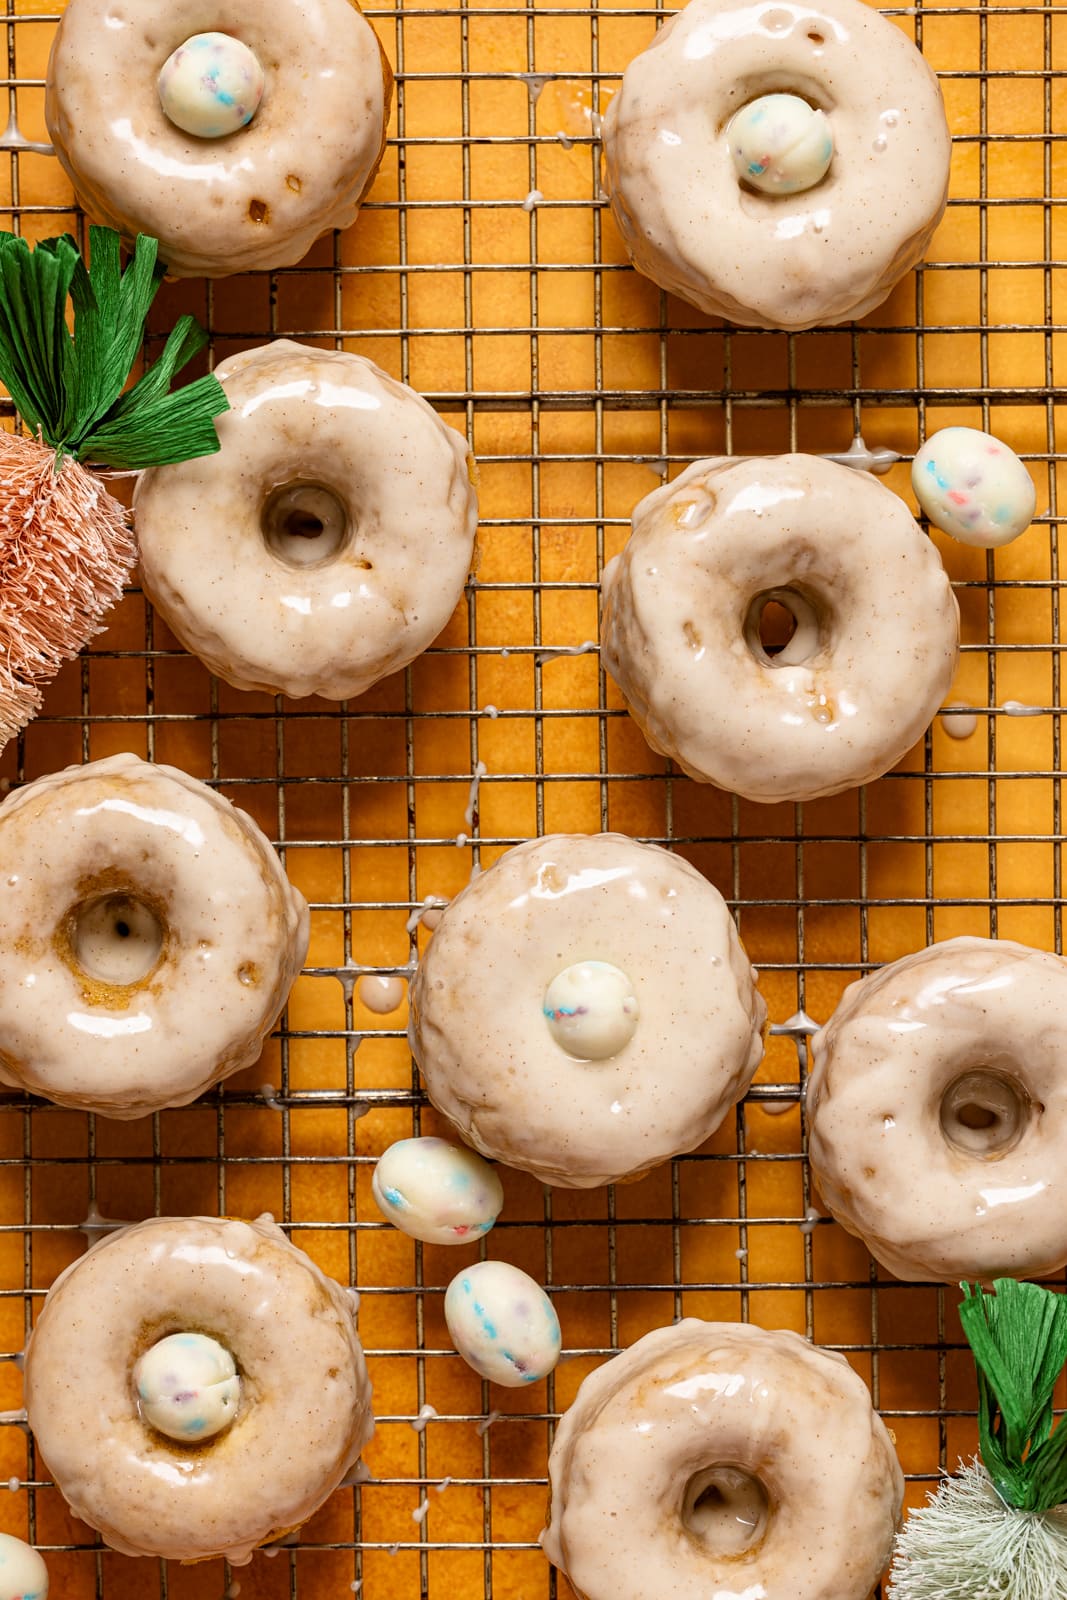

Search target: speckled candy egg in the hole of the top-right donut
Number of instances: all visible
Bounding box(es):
[725,94,833,195]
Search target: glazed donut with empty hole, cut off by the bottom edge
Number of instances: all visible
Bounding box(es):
[541,1317,904,1600]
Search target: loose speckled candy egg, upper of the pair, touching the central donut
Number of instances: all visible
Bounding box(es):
[371,1138,504,1245]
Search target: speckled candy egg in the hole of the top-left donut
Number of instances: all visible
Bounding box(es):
[157,34,264,139]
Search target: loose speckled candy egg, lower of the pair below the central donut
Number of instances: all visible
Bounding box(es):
[445,1261,561,1389]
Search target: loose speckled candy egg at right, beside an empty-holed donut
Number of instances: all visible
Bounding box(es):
[912,427,1037,550]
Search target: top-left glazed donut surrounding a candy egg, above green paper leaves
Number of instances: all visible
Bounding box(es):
[45,0,392,278]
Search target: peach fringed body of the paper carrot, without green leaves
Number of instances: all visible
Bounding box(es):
[0,432,136,747]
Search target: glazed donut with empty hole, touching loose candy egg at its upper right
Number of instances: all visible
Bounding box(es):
[600,456,960,802]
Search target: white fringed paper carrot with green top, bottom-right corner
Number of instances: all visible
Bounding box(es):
[893,1278,1067,1600]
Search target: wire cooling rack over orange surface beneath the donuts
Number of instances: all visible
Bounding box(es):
[0,0,1067,1600]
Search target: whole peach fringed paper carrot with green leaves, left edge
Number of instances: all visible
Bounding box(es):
[0,227,229,746]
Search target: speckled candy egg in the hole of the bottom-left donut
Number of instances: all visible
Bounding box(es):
[133,1333,242,1445]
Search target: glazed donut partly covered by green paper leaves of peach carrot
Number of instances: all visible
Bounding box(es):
[134,339,478,699]
